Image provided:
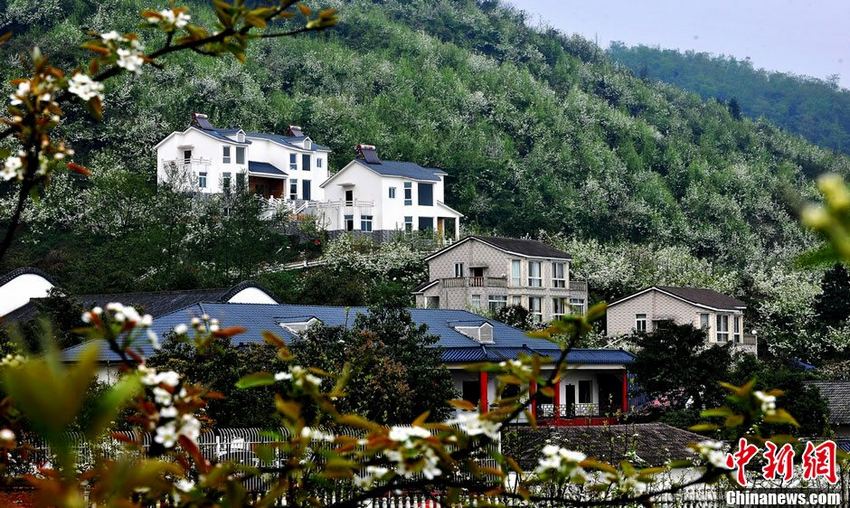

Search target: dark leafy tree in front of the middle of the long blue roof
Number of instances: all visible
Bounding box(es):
[291,306,456,423]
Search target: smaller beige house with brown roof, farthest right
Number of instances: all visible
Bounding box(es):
[606,286,756,353]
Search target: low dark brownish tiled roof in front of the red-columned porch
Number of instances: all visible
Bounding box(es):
[502,423,704,470]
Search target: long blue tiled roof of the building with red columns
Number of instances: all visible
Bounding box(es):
[64,303,633,365]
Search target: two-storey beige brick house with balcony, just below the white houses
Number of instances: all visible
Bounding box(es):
[413,236,587,322]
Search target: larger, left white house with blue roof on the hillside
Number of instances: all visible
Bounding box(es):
[155,113,330,205]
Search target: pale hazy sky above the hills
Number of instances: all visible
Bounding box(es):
[508,0,850,88]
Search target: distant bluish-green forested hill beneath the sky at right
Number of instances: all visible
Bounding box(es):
[608,43,850,153]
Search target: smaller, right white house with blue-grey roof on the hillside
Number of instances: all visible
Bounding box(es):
[311,145,462,239]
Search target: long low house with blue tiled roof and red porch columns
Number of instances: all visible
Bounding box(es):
[64,303,634,425]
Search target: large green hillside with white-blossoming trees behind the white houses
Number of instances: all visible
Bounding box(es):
[0,0,848,274]
